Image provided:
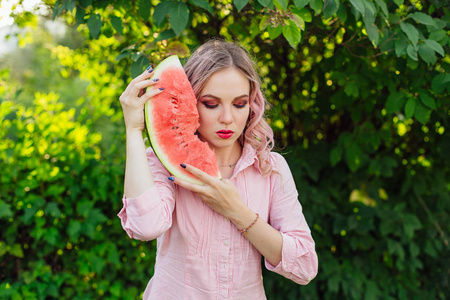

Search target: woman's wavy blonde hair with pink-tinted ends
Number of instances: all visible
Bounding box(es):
[184,40,274,175]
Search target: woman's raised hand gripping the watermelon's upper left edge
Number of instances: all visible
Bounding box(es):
[119,67,162,132]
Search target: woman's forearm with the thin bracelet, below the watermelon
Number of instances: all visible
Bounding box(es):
[232,209,283,266]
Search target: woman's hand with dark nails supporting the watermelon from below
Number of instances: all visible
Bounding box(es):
[174,165,249,221]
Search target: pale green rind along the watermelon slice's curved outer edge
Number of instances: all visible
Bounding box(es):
[144,55,221,184]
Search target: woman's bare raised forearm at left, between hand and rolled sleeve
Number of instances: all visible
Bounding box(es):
[124,130,154,198]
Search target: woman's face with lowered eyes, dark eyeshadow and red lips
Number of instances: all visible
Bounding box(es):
[197,68,250,149]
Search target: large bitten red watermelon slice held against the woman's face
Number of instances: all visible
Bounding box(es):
[145,55,221,184]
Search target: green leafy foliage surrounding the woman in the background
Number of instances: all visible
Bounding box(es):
[0,0,450,299]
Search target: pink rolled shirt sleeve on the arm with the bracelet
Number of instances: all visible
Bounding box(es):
[265,154,318,285]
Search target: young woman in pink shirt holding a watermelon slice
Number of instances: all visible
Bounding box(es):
[119,40,318,299]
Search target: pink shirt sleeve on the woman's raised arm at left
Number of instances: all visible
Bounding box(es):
[118,148,175,241]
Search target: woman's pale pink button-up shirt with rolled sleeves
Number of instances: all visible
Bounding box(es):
[118,145,318,300]
